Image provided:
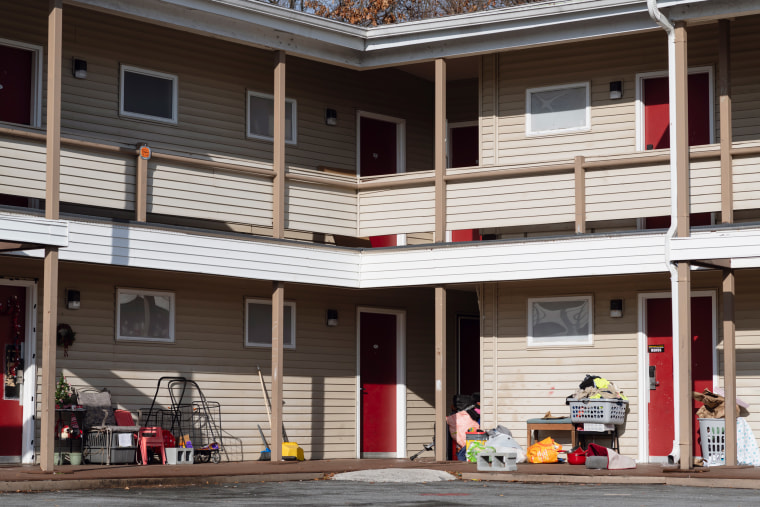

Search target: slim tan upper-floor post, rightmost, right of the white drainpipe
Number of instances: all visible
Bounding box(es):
[718,19,734,224]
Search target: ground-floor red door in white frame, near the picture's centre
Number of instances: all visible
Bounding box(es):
[359,312,397,458]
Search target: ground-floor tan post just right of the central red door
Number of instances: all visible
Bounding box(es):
[435,286,448,461]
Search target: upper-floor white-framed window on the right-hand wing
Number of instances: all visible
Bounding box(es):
[525,81,591,136]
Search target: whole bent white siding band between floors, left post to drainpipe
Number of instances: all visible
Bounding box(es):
[7,220,665,288]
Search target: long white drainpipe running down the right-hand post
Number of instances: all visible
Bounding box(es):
[647,0,681,463]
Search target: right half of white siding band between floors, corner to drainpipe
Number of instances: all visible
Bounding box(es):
[361,233,665,288]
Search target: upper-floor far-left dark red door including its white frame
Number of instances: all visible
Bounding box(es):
[0,38,43,127]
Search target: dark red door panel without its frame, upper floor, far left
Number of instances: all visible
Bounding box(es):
[0,45,34,125]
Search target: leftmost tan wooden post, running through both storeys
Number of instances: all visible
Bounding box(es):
[40,0,63,472]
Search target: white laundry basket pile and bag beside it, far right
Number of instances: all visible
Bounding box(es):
[693,388,760,466]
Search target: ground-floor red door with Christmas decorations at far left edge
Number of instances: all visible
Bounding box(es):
[0,285,25,461]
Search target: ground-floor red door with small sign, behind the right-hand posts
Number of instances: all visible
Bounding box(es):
[646,296,713,459]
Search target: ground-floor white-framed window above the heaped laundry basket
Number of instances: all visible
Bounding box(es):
[528,296,594,346]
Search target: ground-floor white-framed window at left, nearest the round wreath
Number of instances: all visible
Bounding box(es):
[116,287,175,343]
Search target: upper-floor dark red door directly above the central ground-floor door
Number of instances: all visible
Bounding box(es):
[359,116,397,176]
